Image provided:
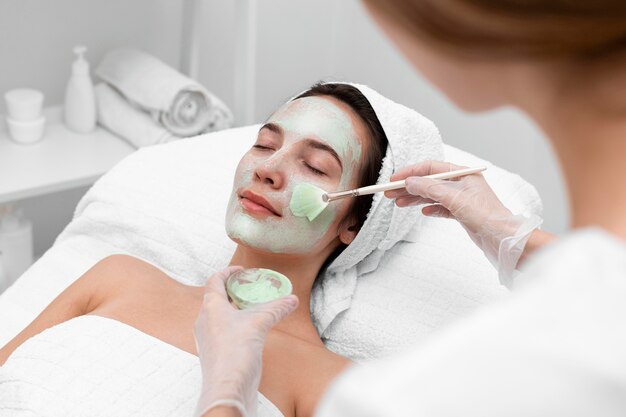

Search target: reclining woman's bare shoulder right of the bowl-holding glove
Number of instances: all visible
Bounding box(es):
[261,331,351,416]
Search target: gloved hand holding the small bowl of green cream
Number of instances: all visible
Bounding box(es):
[194,267,298,417]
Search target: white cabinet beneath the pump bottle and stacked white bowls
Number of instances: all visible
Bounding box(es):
[0,107,135,264]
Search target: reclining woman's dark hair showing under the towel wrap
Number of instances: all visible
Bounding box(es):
[294,83,387,266]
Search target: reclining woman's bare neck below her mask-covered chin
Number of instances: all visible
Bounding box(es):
[230,245,327,342]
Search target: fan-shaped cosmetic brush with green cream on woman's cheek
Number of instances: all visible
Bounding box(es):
[289,167,487,221]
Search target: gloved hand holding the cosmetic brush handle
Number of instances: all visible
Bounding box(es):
[385,161,542,287]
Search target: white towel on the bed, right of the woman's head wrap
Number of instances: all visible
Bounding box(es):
[316,145,542,362]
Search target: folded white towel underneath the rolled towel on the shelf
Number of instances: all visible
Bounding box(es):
[95,83,174,148]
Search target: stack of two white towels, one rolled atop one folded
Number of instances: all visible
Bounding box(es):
[95,48,233,147]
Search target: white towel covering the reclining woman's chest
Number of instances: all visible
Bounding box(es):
[0,315,283,417]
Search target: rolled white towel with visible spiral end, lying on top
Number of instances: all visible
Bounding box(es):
[95,48,234,137]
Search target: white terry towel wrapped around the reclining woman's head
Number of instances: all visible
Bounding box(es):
[298,83,443,336]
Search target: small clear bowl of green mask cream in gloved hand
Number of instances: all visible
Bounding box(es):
[226,268,293,310]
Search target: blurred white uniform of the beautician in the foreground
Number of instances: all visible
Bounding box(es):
[317,229,626,417]
